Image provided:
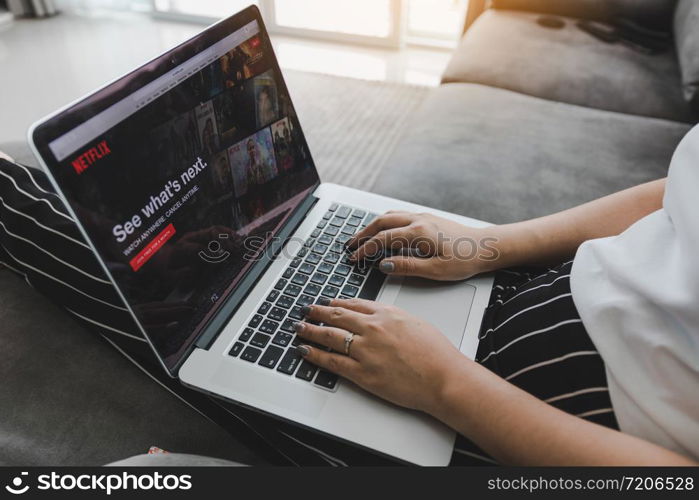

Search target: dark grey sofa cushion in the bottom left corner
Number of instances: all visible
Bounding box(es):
[0,265,260,466]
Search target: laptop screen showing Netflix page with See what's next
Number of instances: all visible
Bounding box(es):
[34,8,318,369]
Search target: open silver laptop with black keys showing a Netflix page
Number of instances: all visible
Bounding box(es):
[29,6,492,465]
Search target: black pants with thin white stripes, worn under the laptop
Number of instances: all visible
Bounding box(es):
[0,159,617,466]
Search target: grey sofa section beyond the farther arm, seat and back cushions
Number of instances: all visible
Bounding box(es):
[374,0,699,223]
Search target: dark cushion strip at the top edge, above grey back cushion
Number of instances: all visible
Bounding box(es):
[493,0,680,30]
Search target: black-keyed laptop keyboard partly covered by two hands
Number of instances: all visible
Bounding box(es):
[228,203,384,391]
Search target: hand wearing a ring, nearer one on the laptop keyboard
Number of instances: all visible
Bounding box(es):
[296,299,469,413]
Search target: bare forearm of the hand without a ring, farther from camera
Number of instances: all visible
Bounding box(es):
[484,179,665,268]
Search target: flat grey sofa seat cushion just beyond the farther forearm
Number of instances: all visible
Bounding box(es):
[373,84,690,223]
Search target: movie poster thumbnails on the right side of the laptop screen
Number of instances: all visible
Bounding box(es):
[146,35,310,226]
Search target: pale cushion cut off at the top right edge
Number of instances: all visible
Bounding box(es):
[675,0,699,113]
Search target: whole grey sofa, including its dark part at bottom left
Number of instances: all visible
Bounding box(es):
[0,0,699,465]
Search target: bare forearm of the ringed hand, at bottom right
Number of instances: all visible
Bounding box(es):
[429,360,696,465]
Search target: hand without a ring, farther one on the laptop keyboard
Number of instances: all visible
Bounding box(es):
[347,211,499,281]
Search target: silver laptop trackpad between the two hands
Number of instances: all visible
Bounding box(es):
[388,277,476,349]
